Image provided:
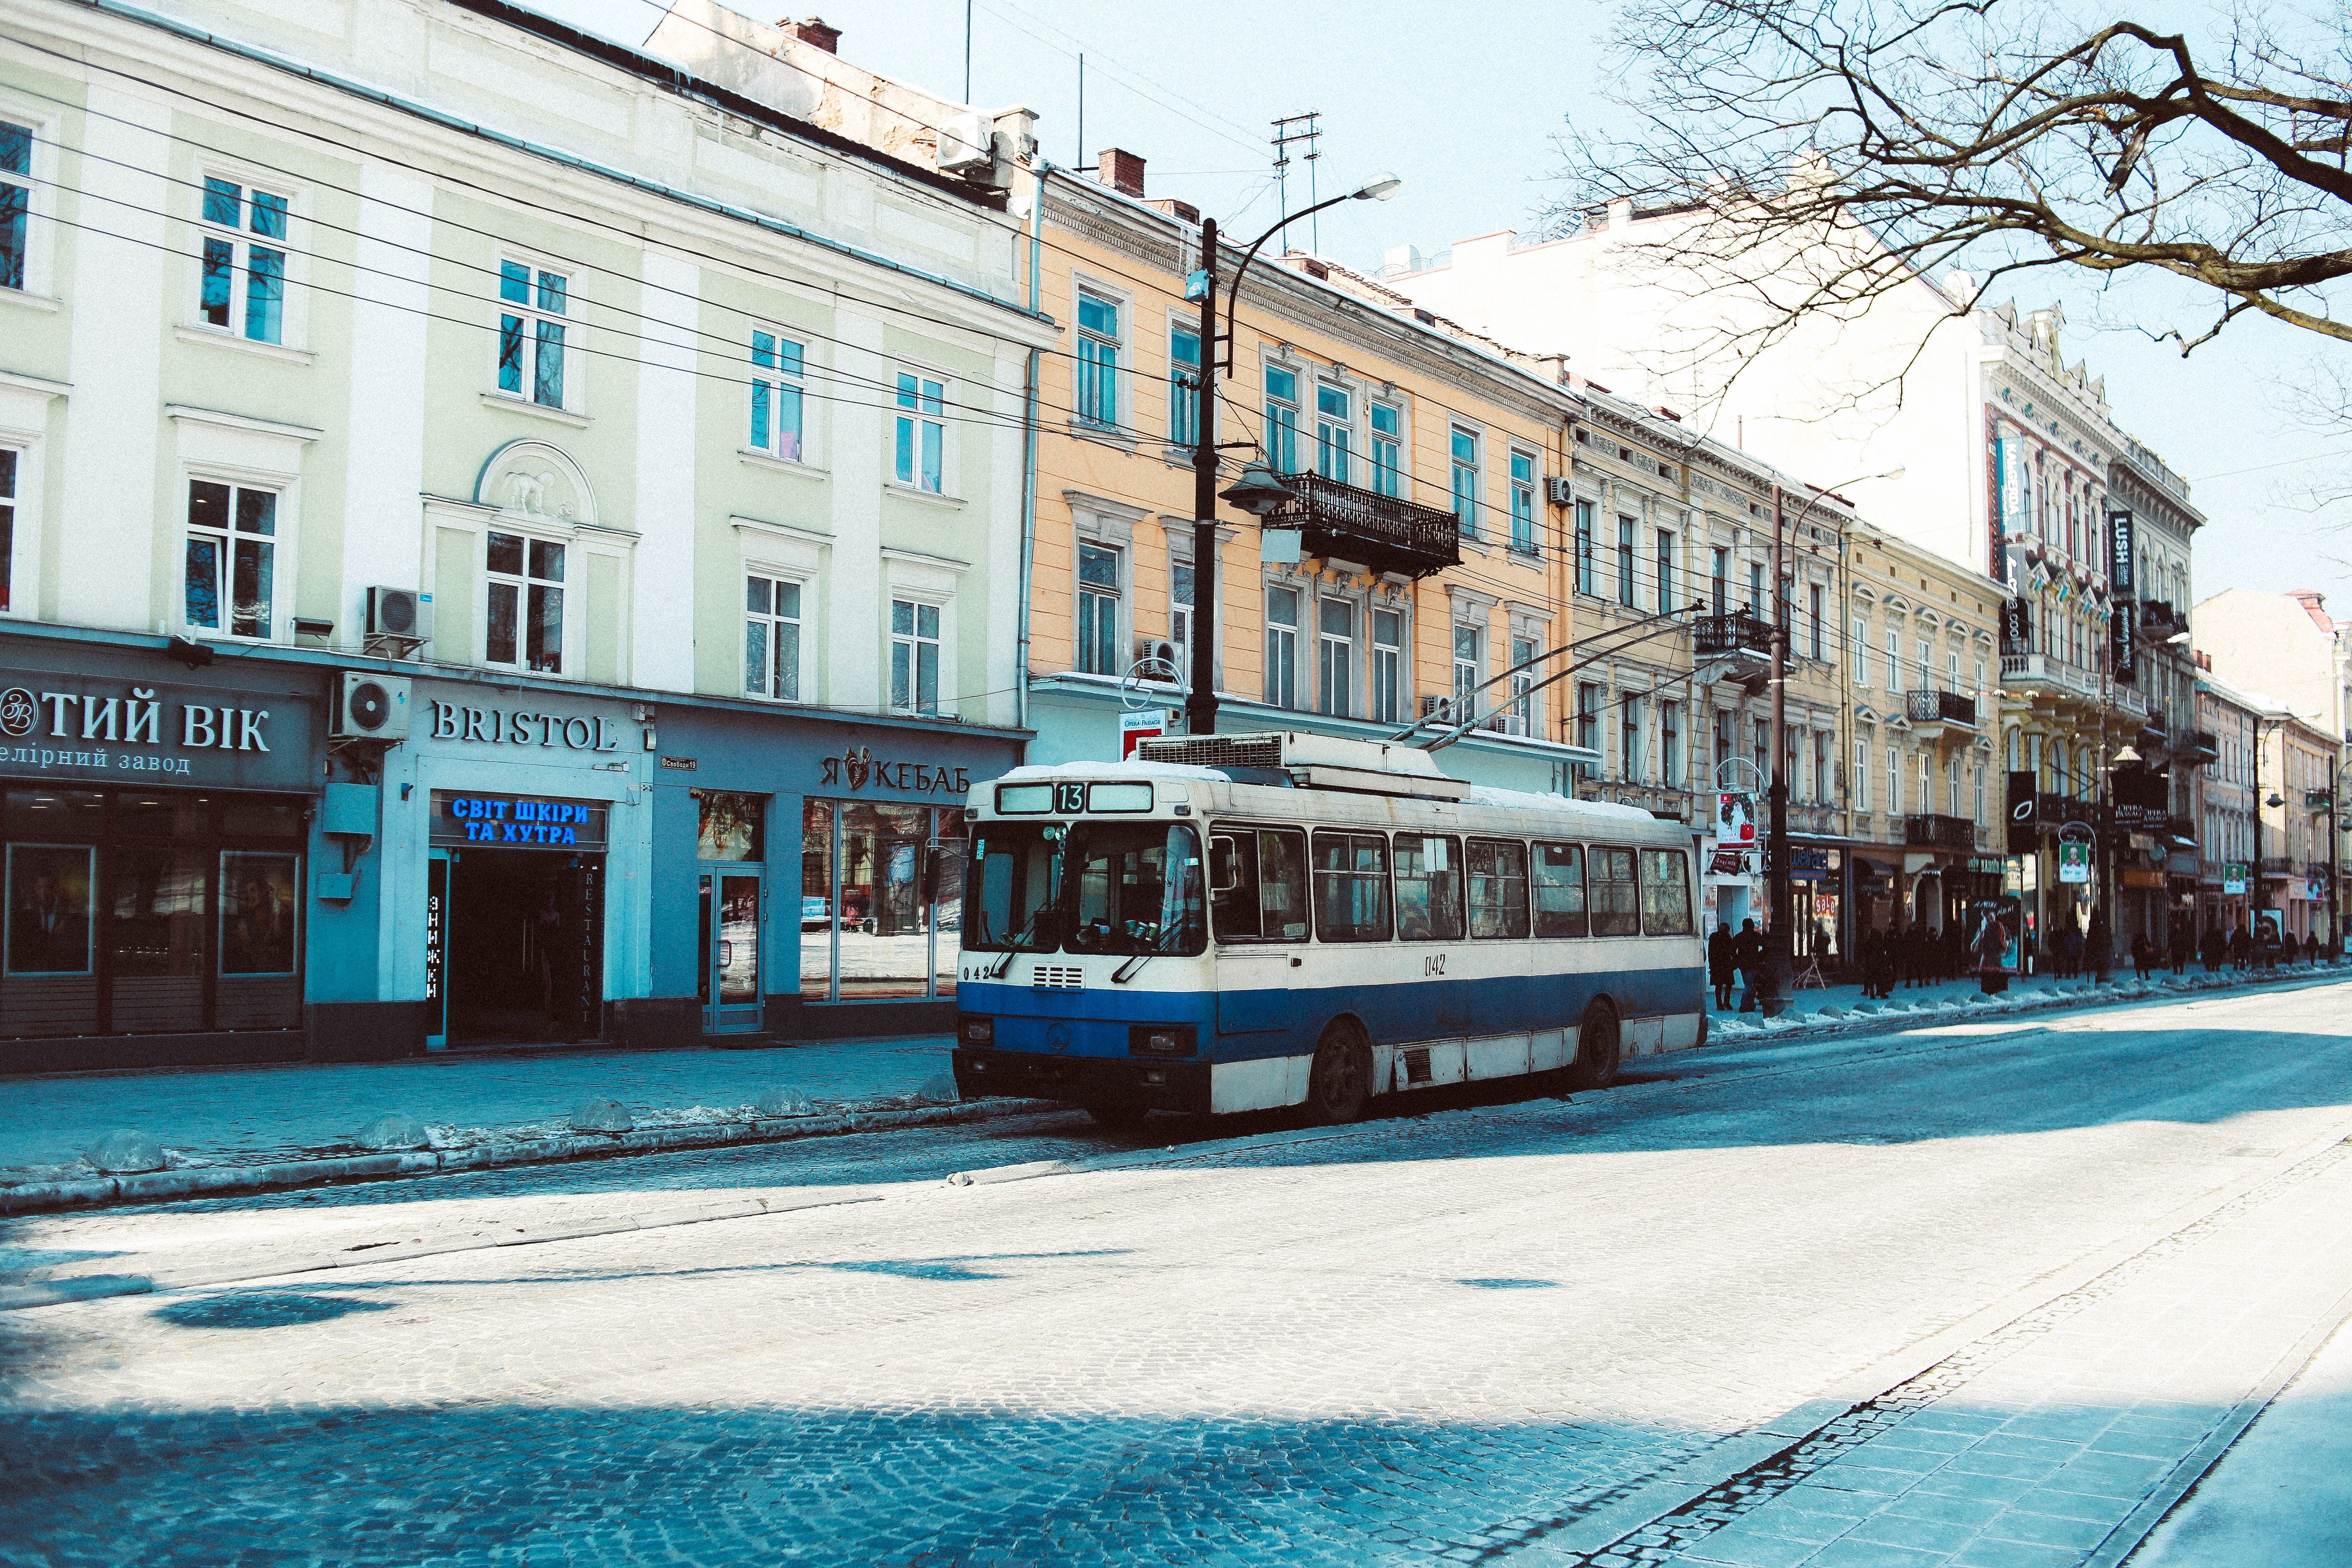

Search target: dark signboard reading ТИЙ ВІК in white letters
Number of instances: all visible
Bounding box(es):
[0,670,318,790]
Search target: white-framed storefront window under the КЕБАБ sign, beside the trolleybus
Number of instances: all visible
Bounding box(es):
[799,799,965,1001]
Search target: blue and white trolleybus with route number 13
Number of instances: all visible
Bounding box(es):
[955,733,1705,1124]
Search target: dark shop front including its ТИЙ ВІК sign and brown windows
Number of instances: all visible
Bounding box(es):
[0,632,318,1072]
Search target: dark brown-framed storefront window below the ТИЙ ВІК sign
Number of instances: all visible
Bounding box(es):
[0,787,303,1039]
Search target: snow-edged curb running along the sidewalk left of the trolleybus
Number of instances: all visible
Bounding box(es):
[0,1100,1068,1216]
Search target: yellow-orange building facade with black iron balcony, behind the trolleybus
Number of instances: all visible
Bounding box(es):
[1016,153,1599,790]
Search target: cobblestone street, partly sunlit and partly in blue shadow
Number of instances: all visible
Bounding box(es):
[0,985,2352,1568]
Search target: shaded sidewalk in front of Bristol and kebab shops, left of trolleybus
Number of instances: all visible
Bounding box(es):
[0,1034,948,1187]
